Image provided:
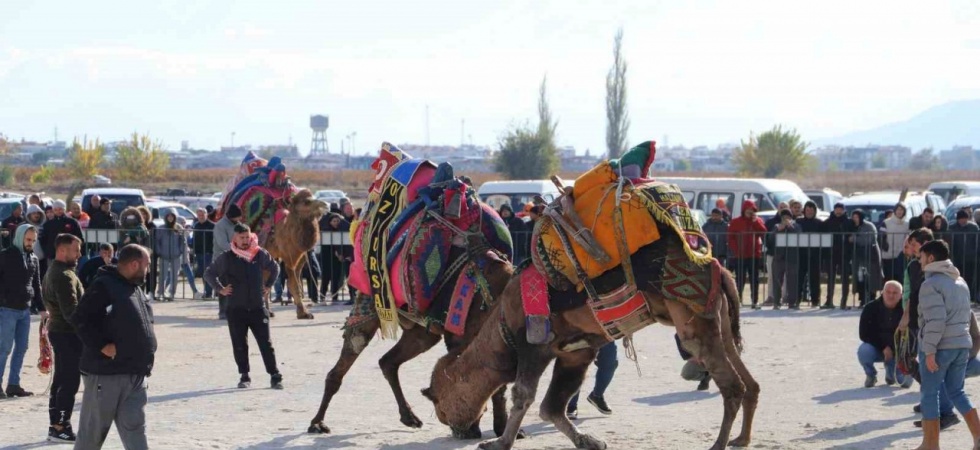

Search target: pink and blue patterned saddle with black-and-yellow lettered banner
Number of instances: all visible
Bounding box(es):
[348,142,513,338]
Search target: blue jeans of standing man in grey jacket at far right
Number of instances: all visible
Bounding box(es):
[919,348,973,420]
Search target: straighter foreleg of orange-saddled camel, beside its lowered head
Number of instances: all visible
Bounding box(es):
[479,346,554,450]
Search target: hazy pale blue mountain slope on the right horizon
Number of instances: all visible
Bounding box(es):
[811,99,980,151]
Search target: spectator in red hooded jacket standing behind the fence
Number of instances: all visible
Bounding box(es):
[728,200,766,309]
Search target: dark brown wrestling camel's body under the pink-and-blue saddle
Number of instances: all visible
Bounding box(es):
[307,243,513,439]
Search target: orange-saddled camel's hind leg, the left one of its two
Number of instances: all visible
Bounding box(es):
[666,301,745,450]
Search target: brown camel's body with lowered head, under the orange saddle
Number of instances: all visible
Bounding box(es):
[422,230,759,450]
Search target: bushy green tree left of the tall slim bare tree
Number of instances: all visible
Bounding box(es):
[494,125,559,180]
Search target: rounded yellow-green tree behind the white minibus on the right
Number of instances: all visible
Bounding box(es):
[732,125,813,178]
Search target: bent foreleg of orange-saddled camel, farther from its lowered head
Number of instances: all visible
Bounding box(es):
[541,349,606,450]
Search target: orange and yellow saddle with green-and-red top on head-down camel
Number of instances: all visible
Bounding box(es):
[521,141,721,343]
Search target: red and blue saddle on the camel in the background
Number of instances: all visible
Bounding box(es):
[218,152,299,247]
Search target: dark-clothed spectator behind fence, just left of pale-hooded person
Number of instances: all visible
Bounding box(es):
[848,209,884,308]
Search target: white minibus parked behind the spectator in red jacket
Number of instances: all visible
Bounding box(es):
[657,177,812,218]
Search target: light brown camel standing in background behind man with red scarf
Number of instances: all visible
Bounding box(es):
[265,189,328,319]
